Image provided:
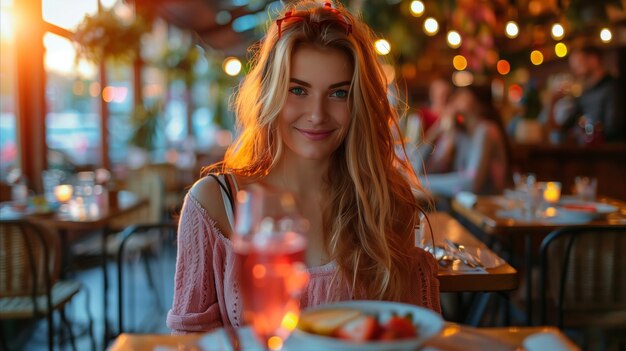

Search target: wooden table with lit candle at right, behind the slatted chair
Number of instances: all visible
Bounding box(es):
[452,196,626,325]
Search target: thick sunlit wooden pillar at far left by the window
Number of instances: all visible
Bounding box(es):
[14,0,48,192]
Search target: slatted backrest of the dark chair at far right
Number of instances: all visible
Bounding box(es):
[540,226,626,327]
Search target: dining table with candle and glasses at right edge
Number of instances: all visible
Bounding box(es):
[451,194,626,325]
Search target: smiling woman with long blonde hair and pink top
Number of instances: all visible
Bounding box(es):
[168,0,440,340]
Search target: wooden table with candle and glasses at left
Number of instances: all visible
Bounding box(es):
[0,190,149,345]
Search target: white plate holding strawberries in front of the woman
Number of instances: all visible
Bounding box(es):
[285,301,444,351]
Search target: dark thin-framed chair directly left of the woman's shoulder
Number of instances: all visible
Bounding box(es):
[117,222,178,334]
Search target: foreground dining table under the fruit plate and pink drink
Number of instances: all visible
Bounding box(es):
[109,323,580,351]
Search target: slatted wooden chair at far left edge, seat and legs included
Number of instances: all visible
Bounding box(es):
[0,220,95,351]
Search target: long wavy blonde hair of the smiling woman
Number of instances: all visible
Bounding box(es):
[210,0,426,301]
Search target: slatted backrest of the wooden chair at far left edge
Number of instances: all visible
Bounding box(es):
[0,220,61,297]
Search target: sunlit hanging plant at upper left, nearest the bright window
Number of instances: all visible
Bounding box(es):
[72,9,148,63]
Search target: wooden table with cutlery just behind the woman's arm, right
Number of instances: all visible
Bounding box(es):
[426,212,518,292]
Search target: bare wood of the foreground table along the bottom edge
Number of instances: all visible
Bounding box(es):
[109,323,578,351]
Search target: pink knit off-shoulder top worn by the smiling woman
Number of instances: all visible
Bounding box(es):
[167,194,441,334]
